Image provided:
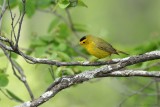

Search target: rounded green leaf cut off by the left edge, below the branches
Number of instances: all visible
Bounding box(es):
[0,73,9,87]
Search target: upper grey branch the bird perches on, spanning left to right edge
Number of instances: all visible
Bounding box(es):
[0,36,160,67]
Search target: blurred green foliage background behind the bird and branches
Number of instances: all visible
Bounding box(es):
[0,0,160,107]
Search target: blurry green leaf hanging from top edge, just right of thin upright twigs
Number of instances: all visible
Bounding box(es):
[26,0,36,17]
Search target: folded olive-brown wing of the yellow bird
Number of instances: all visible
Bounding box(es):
[95,38,118,54]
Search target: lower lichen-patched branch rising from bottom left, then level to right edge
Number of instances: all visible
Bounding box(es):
[16,69,160,107]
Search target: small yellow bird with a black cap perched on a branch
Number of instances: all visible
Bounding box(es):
[79,35,128,58]
